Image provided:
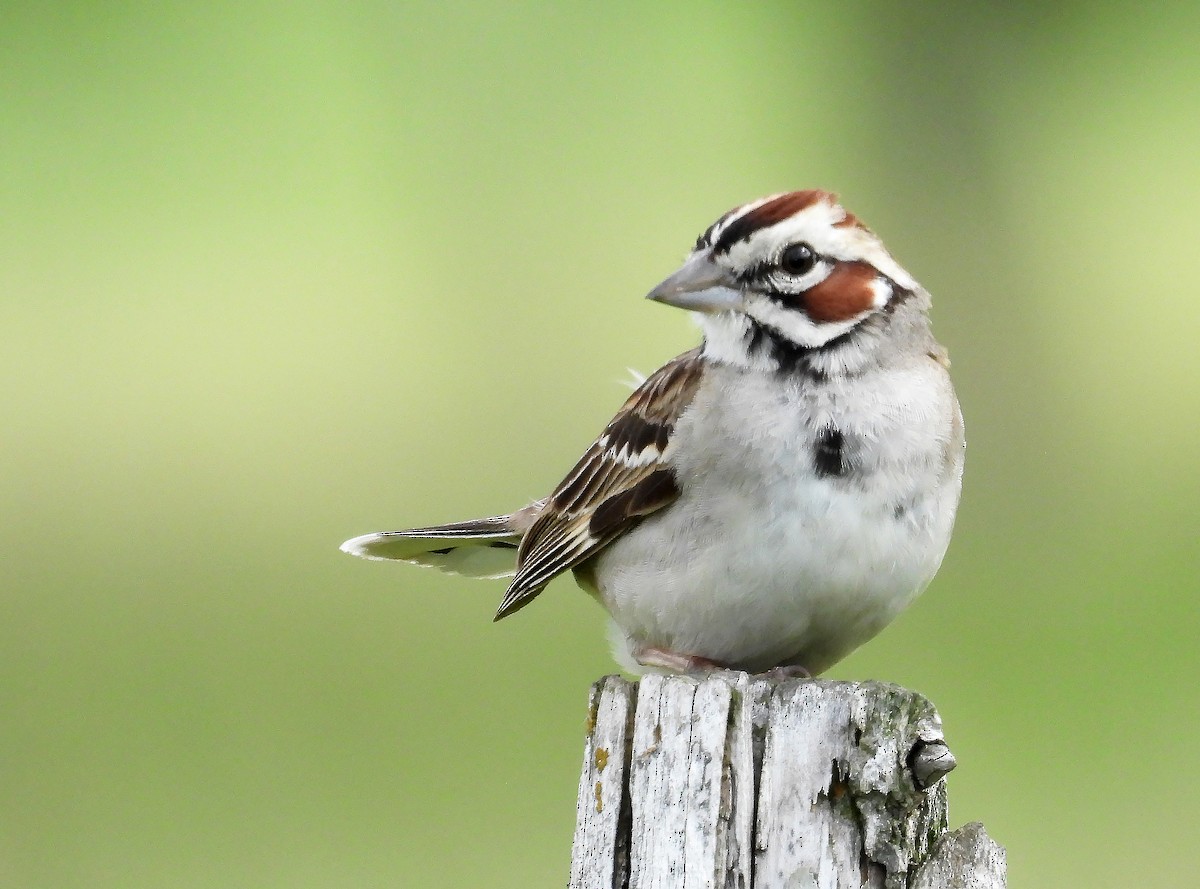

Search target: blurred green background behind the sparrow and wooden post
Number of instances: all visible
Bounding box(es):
[0,0,1200,889]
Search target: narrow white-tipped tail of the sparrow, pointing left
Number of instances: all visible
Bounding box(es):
[342,507,528,578]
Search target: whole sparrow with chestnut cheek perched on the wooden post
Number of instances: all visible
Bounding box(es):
[342,188,966,675]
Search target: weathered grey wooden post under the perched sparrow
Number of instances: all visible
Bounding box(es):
[569,672,1004,889]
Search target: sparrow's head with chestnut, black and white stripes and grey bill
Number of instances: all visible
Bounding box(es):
[648,190,929,373]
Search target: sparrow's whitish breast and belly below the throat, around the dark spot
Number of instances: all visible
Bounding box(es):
[593,356,962,673]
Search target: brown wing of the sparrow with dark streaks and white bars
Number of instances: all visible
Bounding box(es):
[496,349,702,620]
